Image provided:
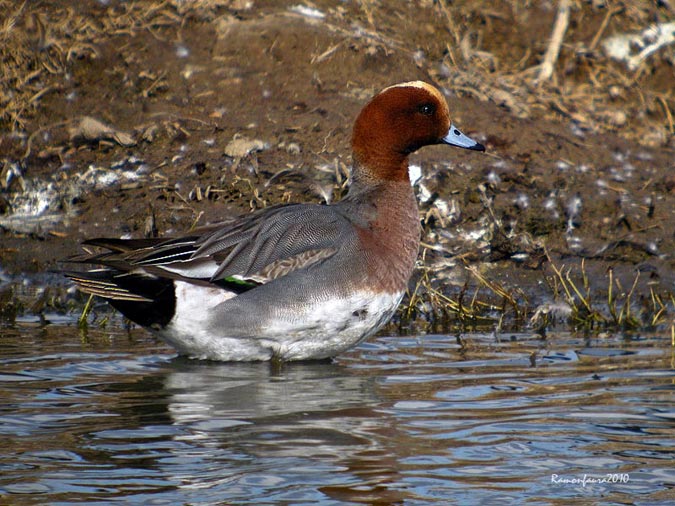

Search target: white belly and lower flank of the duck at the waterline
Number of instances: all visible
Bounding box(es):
[158,282,403,361]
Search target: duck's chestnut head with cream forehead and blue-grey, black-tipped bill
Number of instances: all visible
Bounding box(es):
[352,81,485,185]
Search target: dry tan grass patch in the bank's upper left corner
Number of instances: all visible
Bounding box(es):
[0,0,181,135]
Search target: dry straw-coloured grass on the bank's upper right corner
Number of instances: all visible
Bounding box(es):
[436,0,675,146]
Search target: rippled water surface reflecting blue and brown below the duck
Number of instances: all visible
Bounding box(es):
[0,322,675,504]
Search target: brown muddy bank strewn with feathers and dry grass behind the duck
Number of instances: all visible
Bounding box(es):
[0,0,675,324]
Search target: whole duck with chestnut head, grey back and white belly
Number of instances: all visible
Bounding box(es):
[66,81,485,361]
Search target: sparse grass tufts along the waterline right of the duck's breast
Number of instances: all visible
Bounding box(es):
[400,244,675,334]
